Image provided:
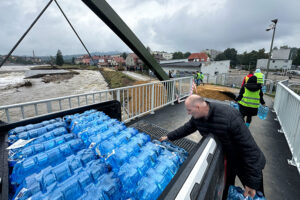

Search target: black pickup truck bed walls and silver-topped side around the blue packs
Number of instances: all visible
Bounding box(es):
[0,101,224,199]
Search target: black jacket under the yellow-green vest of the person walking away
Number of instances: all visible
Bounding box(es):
[235,76,265,116]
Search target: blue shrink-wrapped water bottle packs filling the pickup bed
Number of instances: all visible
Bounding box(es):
[8,110,188,200]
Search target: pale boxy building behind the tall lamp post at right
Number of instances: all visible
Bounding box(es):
[256,49,293,70]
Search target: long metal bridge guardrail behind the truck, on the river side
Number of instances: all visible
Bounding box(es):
[0,77,192,123]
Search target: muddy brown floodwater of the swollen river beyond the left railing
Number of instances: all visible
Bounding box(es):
[0,66,108,121]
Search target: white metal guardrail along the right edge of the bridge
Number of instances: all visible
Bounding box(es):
[274,80,300,173]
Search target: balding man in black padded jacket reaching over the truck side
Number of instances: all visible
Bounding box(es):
[160,95,266,199]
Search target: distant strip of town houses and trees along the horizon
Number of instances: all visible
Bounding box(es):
[0,46,300,74]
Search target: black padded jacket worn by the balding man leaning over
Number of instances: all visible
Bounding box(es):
[168,102,266,190]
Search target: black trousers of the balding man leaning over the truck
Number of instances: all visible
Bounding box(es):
[222,161,265,200]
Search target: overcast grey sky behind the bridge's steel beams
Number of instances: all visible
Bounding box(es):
[0,0,300,56]
